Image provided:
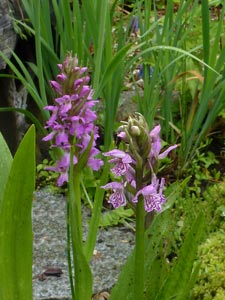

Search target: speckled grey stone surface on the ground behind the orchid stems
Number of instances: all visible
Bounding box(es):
[33,188,134,300]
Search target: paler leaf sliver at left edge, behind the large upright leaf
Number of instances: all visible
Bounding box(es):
[0,133,12,207]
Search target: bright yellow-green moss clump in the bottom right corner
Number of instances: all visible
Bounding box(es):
[191,230,225,300]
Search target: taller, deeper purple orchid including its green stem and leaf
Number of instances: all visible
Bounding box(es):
[43,53,103,300]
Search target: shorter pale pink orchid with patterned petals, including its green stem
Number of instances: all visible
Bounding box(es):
[102,113,177,300]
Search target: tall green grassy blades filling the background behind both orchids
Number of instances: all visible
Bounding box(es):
[1,0,225,175]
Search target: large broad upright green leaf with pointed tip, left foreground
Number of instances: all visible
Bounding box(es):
[0,126,35,300]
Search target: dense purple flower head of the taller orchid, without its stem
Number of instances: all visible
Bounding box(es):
[43,53,103,186]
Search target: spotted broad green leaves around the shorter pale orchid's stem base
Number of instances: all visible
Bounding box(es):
[110,203,204,300]
